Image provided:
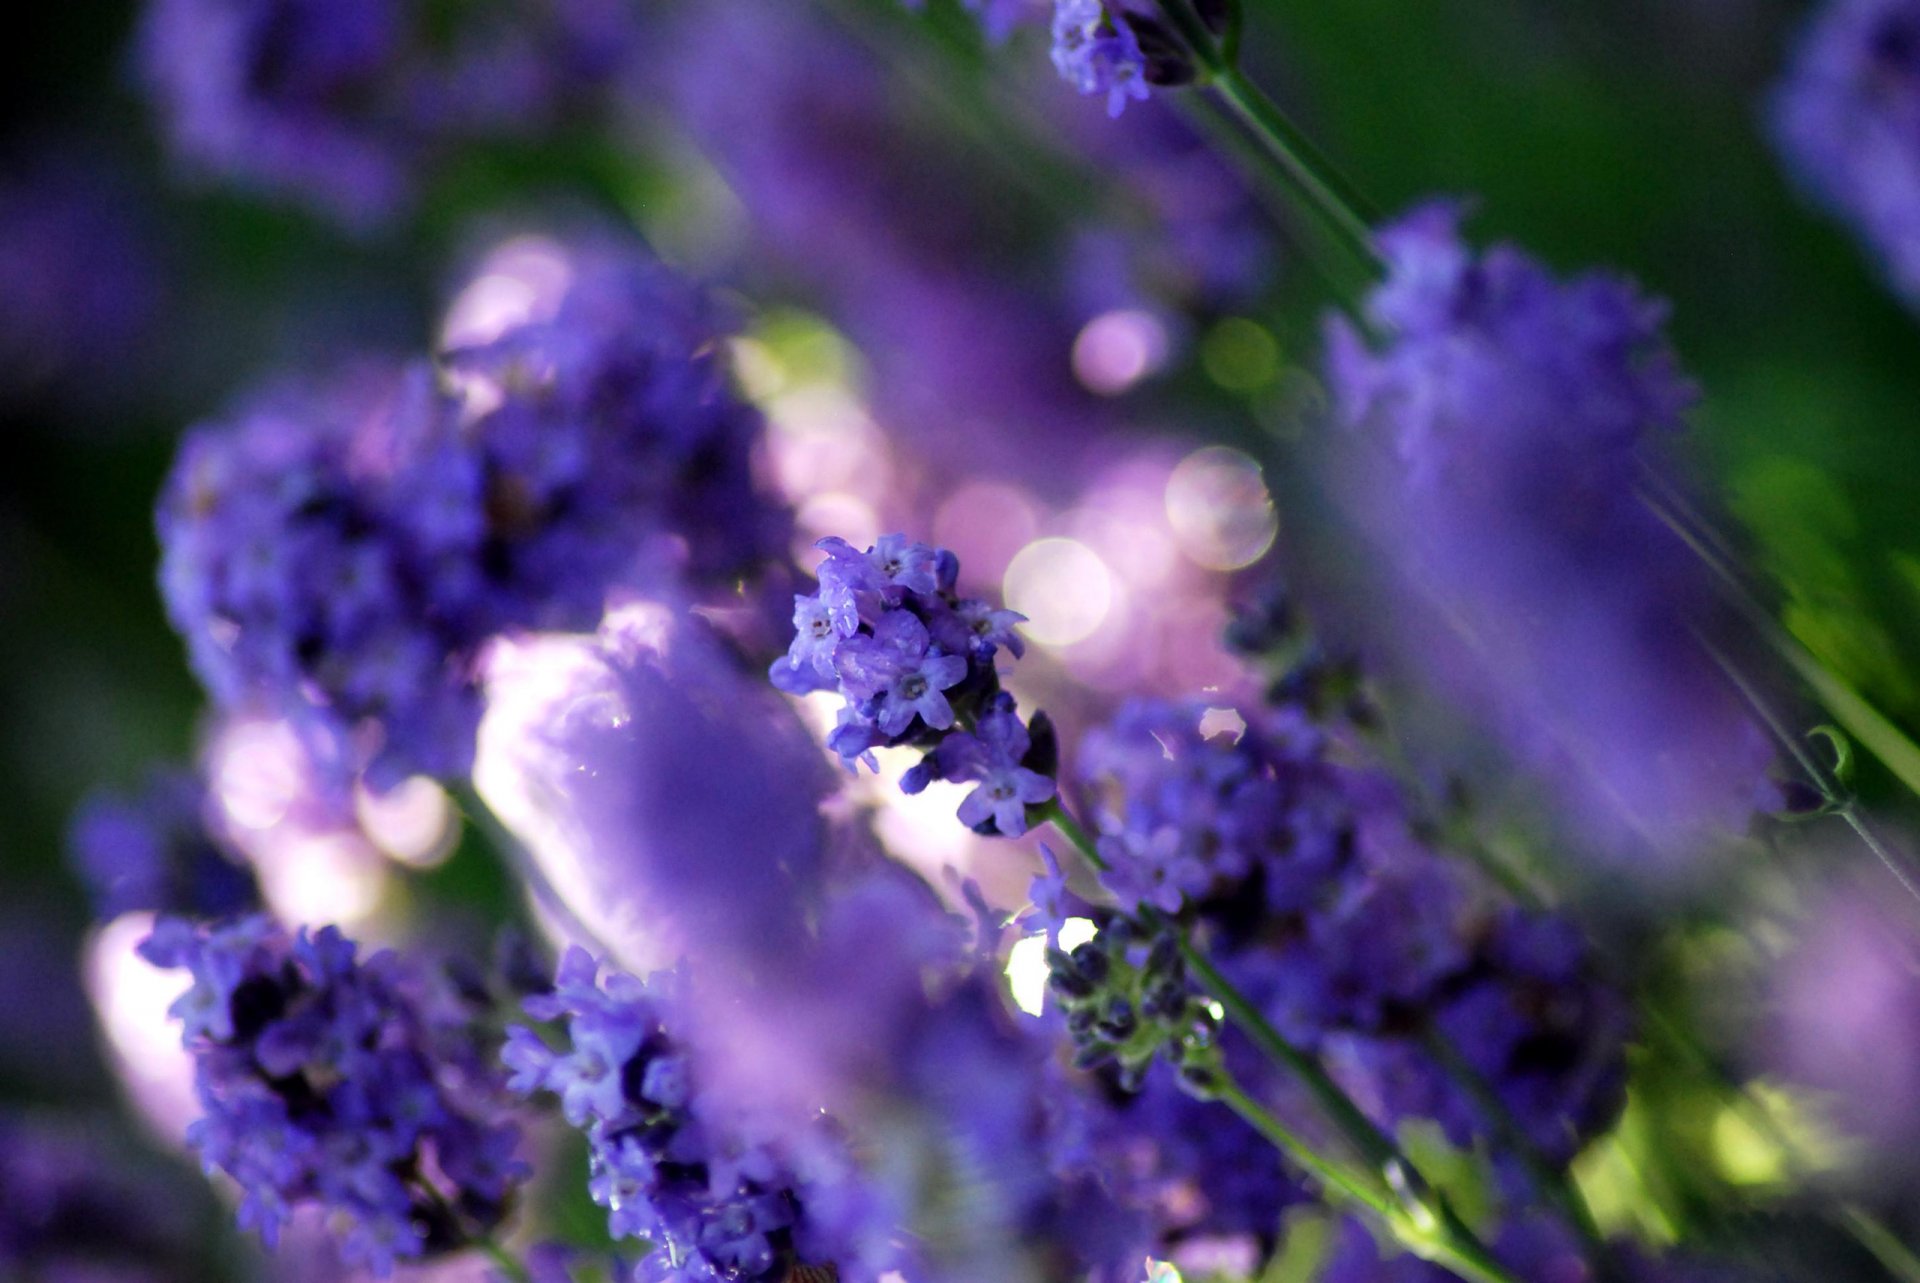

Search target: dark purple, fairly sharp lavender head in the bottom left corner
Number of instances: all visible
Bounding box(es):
[140,918,526,1275]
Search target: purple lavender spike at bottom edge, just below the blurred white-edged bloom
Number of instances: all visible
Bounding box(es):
[503,949,871,1283]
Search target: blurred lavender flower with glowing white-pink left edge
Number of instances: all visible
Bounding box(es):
[474,607,831,983]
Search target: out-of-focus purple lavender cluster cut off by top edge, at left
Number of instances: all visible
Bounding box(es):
[138,0,639,229]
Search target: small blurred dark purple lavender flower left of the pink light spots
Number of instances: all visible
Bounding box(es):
[67,770,259,920]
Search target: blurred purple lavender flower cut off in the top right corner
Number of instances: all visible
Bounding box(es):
[1768,0,1920,303]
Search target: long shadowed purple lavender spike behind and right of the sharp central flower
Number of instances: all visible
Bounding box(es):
[1075,703,1628,1162]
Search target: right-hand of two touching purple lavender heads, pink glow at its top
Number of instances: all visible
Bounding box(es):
[433,232,789,603]
